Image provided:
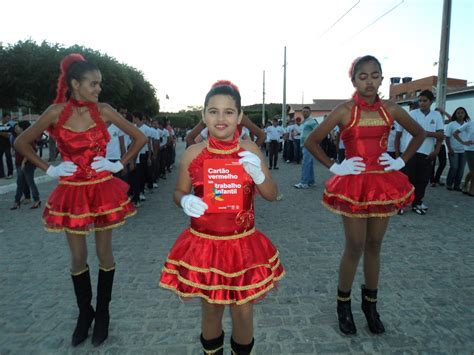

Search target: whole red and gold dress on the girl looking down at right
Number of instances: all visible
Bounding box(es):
[323,96,414,218]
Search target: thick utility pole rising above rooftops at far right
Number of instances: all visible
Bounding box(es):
[436,0,452,109]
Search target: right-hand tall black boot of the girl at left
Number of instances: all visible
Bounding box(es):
[92,266,115,346]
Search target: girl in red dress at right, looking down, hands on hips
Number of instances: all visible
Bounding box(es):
[305,56,425,334]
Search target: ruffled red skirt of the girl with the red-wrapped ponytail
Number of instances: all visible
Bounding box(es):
[43,176,136,235]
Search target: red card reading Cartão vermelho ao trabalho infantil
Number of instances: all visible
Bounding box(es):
[203,159,245,213]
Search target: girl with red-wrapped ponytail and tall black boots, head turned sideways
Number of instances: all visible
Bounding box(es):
[15,54,146,346]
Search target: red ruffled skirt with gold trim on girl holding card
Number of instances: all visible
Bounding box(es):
[160,228,285,305]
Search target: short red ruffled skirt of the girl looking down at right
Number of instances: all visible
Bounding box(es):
[322,171,415,218]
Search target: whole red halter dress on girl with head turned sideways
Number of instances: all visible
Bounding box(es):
[43,99,136,235]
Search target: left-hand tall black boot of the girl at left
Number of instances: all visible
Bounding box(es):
[71,266,94,346]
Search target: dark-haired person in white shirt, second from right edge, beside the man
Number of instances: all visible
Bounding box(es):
[438,107,470,191]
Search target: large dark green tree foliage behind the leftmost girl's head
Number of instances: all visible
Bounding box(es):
[0,40,159,115]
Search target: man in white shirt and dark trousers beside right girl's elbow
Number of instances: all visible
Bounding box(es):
[402,90,444,215]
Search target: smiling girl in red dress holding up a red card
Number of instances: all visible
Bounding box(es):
[160,81,284,354]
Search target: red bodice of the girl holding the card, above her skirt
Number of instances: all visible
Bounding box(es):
[188,136,255,236]
